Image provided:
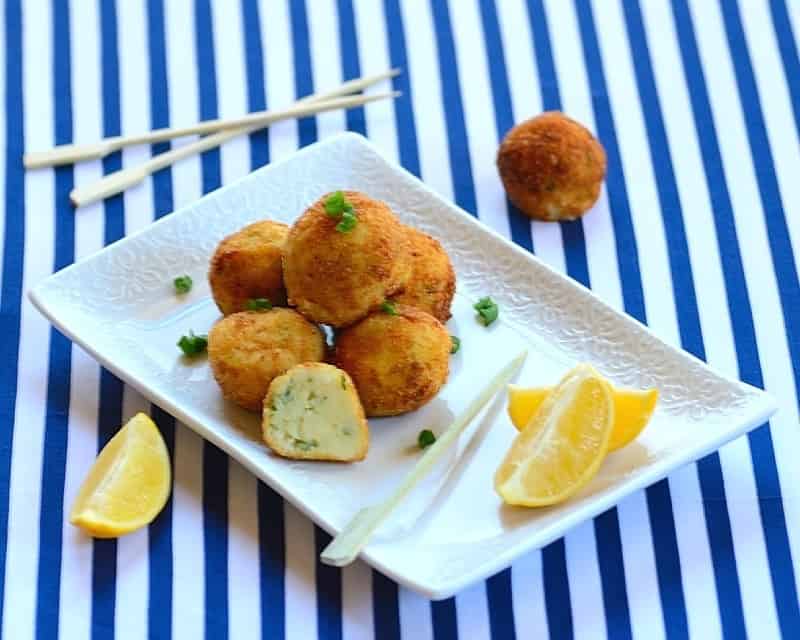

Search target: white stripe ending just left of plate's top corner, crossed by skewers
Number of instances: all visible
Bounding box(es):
[306,0,346,140]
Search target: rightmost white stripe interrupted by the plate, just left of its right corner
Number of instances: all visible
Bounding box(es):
[648,5,778,635]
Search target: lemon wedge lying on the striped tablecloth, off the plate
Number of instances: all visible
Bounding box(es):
[69,413,171,538]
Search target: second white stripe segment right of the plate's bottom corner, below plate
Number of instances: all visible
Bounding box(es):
[511,551,548,638]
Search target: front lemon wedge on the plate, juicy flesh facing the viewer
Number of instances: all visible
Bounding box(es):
[494,365,614,507]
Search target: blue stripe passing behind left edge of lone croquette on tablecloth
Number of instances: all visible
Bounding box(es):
[480,0,533,251]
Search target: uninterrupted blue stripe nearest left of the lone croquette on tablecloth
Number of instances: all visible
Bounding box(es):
[431,2,478,216]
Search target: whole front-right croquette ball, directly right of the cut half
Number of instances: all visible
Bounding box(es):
[334,305,451,416]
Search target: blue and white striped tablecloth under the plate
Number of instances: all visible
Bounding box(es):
[0,0,800,640]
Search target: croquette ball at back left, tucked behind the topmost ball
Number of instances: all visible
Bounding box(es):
[208,220,289,316]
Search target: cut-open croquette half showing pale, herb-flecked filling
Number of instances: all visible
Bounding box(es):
[262,362,369,462]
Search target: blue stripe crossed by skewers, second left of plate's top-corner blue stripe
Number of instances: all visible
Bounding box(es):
[242,0,269,169]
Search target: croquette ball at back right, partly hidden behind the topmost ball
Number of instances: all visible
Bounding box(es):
[392,227,456,322]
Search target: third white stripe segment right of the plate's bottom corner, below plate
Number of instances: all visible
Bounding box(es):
[564,521,606,639]
